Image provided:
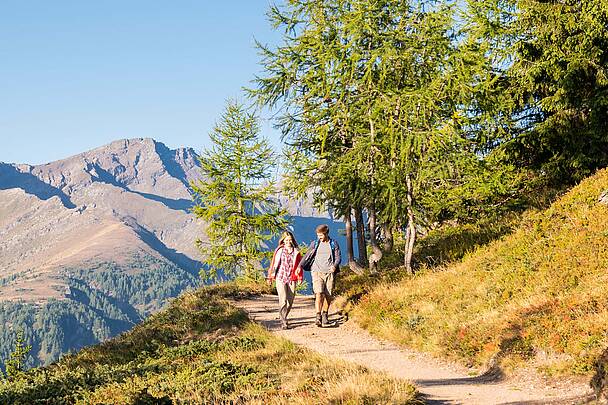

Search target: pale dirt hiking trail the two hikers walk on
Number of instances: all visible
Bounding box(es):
[234,295,594,405]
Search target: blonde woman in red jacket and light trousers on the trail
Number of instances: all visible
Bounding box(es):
[268,231,302,329]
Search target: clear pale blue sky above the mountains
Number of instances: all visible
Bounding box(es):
[0,0,279,164]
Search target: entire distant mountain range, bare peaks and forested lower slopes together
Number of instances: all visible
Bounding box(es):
[0,138,339,365]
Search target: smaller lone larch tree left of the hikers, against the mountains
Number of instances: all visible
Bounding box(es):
[192,102,287,279]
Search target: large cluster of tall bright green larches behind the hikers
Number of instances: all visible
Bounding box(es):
[251,0,512,271]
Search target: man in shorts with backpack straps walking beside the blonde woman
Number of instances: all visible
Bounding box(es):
[302,225,342,326]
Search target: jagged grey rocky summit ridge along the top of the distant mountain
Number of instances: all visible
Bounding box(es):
[0,138,199,204]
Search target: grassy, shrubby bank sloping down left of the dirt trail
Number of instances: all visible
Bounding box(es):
[0,284,419,404]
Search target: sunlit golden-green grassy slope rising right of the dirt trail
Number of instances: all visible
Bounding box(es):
[353,170,608,374]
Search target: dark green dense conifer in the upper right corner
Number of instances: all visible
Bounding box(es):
[508,0,608,185]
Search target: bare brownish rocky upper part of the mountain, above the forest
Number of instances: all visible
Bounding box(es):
[0,139,201,300]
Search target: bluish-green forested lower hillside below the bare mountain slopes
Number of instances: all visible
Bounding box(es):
[0,253,200,367]
